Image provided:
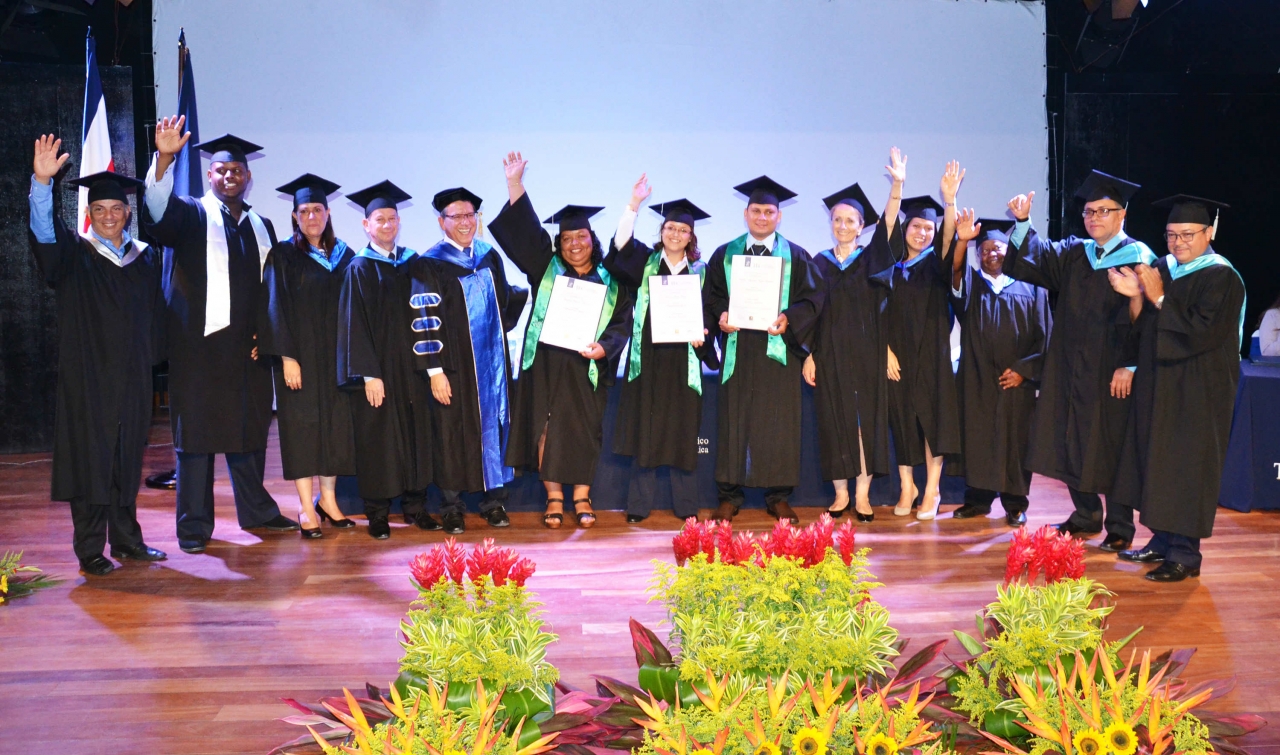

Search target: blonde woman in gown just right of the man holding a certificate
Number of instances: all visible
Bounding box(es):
[804,175,901,522]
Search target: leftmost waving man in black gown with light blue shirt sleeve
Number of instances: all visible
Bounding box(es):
[31,134,165,576]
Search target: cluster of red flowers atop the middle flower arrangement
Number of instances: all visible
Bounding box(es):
[671,513,855,567]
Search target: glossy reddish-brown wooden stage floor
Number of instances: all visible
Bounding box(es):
[0,424,1280,755]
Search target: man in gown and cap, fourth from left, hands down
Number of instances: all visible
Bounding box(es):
[337,180,443,540]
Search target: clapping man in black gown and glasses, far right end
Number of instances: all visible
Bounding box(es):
[1110,195,1244,582]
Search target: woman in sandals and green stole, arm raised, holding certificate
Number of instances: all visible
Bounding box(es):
[489,152,632,529]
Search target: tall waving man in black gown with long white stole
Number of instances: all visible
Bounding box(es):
[145,118,298,553]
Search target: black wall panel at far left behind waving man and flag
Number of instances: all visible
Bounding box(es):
[0,63,134,453]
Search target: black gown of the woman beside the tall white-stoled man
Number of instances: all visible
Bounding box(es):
[257,238,356,480]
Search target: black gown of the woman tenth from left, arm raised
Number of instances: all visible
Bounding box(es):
[876,243,961,466]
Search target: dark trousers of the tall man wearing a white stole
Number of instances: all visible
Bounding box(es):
[178,449,280,541]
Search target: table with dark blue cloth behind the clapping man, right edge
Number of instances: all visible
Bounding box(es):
[1217,361,1280,512]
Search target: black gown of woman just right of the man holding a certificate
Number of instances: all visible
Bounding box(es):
[813,224,893,480]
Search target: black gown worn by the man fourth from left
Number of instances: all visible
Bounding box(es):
[337,247,439,500]
